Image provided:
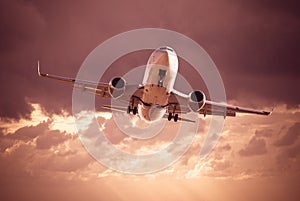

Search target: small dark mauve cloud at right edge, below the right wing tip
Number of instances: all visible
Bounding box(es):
[274,122,300,147]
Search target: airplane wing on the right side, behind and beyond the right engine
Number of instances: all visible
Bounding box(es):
[168,90,271,117]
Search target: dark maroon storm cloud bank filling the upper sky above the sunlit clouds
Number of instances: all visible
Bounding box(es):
[0,0,300,118]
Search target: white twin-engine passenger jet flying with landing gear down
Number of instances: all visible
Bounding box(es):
[38,46,271,123]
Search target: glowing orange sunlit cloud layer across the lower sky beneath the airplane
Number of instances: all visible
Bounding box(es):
[0,103,299,200]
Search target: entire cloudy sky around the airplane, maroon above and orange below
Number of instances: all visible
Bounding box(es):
[0,0,300,201]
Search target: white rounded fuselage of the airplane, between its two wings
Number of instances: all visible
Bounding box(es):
[138,47,178,122]
